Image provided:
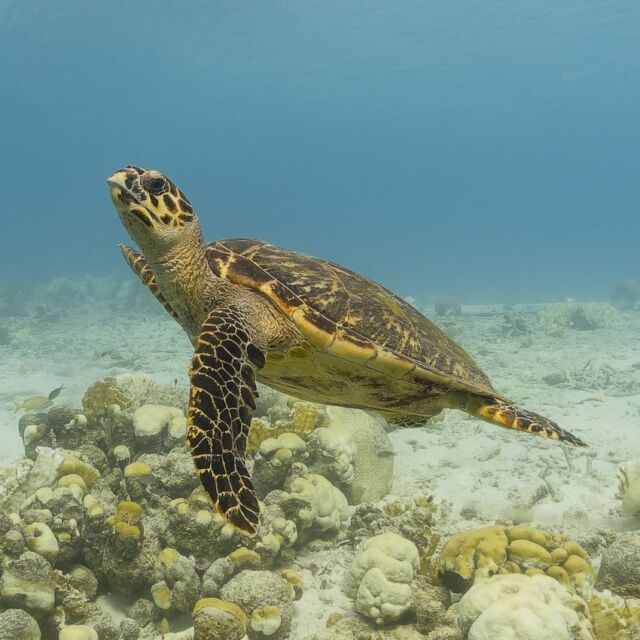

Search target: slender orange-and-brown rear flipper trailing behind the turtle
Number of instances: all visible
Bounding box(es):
[461,395,588,447]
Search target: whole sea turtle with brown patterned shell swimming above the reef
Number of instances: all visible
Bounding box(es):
[107,166,584,534]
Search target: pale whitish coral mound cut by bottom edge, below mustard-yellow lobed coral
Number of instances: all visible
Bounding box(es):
[458,574,594,640]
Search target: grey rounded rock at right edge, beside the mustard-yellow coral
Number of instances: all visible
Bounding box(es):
[596,531,640,598]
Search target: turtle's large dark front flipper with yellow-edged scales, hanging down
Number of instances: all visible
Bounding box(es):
[187,305,265,534]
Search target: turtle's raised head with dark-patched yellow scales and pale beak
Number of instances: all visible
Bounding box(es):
[107,166,200,250]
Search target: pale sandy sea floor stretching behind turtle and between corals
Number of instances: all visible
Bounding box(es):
[0,281,640,638]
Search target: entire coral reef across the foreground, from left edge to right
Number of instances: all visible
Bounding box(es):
[0,377,624,640]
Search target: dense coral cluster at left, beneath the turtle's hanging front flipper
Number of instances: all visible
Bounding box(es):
[0,377,384,640]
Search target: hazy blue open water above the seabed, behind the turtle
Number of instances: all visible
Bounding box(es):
[0,0,640,302]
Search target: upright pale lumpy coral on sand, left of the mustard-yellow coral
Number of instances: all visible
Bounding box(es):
[345,533,420,624]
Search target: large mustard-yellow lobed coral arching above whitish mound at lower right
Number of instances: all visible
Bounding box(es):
[438,526,595,599]
